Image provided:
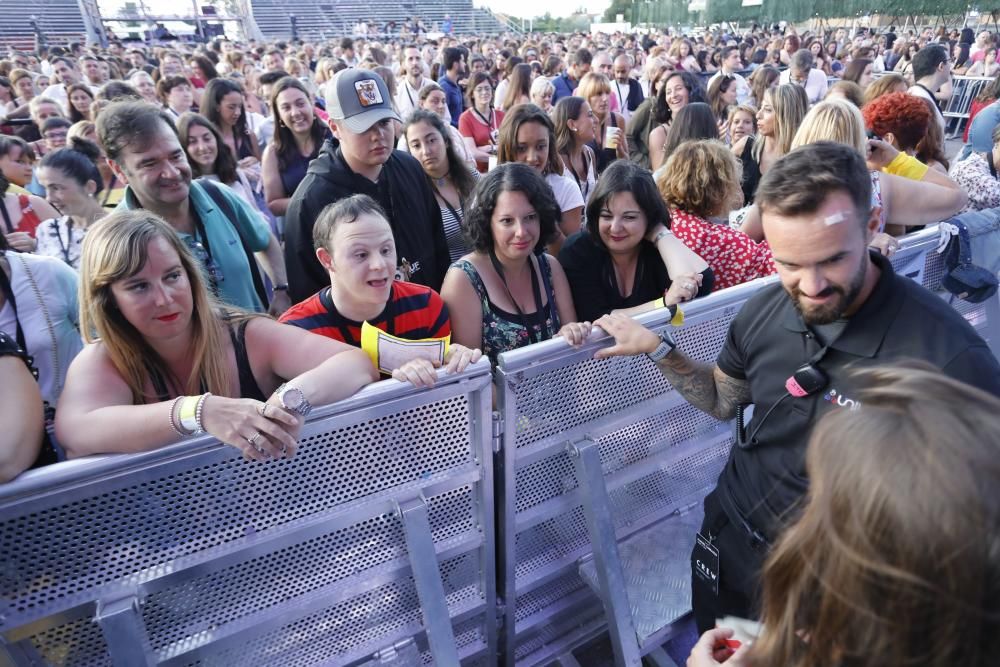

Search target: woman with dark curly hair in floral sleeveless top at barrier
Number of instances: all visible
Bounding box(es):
[441,164,590,364]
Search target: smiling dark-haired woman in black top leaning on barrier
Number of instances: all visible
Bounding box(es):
[559,159,713,320]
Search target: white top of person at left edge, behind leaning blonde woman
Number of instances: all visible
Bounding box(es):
[0,253,83,407]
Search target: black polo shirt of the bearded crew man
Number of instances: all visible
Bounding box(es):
[716,253,1000,538]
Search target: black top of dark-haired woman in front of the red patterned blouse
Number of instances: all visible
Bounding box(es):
[559,230,668,322]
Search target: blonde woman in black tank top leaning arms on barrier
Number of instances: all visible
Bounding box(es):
[56,210,377,460]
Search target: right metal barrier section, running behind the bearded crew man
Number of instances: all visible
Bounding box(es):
[497,228,1000,665]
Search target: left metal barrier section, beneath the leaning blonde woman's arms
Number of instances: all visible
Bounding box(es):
[0,360,497,667]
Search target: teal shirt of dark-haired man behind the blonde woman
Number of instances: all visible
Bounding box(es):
[115,181,271,312]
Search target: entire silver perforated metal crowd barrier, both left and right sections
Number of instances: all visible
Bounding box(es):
[0,228,1000,667]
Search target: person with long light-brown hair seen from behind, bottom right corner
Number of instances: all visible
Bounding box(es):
[687,366,1000,667]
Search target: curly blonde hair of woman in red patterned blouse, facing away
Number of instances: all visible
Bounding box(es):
[656,139,743,218]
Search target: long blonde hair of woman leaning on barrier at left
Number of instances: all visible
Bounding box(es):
[79,210,231,403]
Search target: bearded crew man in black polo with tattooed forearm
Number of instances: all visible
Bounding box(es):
[594,142,1000,632]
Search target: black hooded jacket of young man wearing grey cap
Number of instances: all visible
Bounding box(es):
[285,140,449,303]
